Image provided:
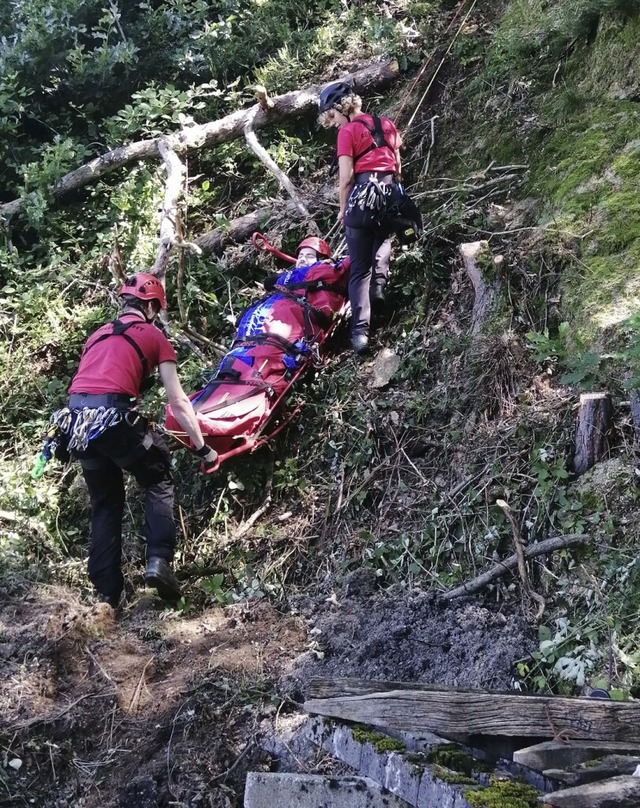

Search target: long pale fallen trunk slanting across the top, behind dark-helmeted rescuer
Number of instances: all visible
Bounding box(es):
[0,60,399,220]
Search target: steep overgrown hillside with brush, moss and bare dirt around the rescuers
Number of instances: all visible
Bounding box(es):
[0,0,640,808]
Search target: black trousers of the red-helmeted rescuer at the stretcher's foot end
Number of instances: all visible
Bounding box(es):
[74,418,176,597]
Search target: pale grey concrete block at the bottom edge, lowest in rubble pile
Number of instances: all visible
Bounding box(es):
[244,772,408,808]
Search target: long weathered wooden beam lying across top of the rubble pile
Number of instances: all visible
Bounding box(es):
[304,679,640,743]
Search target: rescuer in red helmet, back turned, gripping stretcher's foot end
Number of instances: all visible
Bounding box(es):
[66,273,217,608]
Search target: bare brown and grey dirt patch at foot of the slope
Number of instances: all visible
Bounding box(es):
[0,574,529,808]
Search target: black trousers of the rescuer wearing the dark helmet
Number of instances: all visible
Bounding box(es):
[345,227,391,336]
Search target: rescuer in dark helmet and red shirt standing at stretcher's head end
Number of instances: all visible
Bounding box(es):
[320,82,402,353]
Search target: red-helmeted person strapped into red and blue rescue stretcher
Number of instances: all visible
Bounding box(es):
[165,233,349,471]
